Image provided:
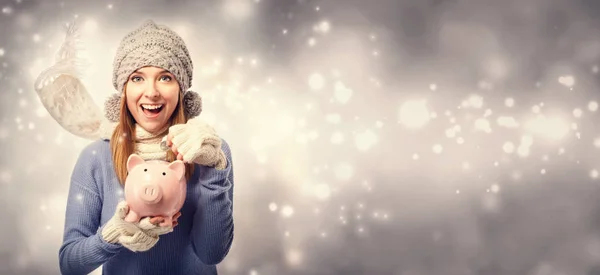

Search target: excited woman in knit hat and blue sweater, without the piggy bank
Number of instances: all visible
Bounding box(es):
[59,21,233,274]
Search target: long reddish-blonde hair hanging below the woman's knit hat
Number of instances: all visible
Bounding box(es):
[110,87,194,185]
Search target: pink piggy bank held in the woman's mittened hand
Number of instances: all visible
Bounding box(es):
[125,154,187,226]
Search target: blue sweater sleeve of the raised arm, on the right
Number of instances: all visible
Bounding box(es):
[191,140,233,265]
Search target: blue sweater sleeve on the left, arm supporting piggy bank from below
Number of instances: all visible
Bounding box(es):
[59,143,123,274]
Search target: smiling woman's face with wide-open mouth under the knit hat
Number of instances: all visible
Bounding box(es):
[125,67,179,133]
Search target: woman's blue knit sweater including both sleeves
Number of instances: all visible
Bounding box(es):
[59,140,233,275]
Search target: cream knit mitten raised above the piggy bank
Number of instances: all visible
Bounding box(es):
[169,117,227,170]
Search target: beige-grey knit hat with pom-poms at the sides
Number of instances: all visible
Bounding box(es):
[104,20,202,122]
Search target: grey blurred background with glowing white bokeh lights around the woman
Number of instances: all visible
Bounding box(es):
[0,0,600,275]
